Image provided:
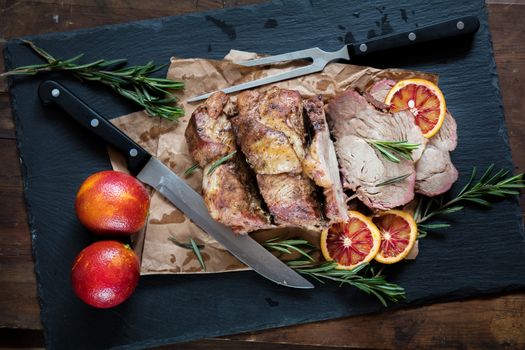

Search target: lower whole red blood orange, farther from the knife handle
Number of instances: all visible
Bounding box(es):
[71,241,140,308]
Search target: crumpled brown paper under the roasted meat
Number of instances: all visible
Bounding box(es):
[110,51,437,275]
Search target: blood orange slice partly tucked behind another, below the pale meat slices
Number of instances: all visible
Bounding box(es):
[372,210,417,264]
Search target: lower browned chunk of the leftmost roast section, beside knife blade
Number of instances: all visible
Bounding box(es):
[202,157,274,234]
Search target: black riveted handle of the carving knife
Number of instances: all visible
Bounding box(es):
[38,80,151,175]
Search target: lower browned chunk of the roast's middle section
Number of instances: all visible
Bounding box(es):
[257,174,322,231]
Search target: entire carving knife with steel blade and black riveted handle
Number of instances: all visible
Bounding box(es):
[38,80,314,289]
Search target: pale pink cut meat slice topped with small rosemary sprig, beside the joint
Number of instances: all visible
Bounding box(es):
[327,89,426,210]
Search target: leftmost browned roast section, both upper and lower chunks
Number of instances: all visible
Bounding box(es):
[185,92,273,233]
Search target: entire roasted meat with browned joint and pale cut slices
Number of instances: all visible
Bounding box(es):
[185,79,458,233]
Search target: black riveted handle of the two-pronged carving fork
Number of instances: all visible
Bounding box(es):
[348,16,479,58]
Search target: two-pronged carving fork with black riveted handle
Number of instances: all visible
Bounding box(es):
[187,16,479,102]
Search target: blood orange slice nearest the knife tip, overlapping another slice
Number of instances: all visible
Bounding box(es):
[321,210,380,270]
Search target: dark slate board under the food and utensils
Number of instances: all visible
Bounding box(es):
[6,0,525,349]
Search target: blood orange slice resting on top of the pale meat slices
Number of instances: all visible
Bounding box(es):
[385,79,447,138]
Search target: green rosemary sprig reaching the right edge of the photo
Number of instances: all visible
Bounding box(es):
[414,164,525,232]
